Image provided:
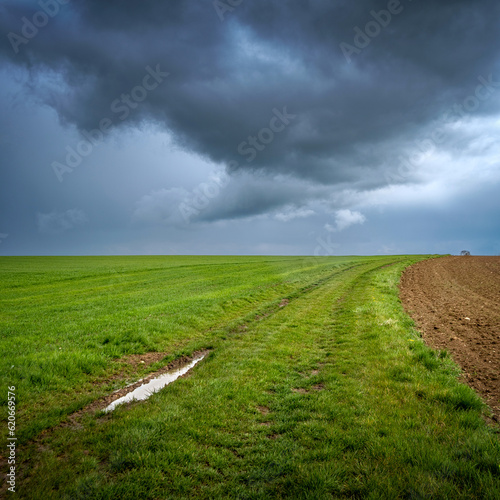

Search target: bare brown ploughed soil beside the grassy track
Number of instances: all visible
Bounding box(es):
[400,257,500,422]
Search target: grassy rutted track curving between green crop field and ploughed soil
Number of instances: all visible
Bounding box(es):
[4,258,500,499]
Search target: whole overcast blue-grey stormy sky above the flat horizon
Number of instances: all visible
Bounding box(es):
[0,0,500,255]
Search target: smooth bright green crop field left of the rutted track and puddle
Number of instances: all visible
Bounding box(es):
[0,257,373,443]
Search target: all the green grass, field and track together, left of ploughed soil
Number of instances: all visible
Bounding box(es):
[0,256,500,499]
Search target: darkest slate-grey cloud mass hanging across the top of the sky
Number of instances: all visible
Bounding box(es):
[0,0,500,186]
